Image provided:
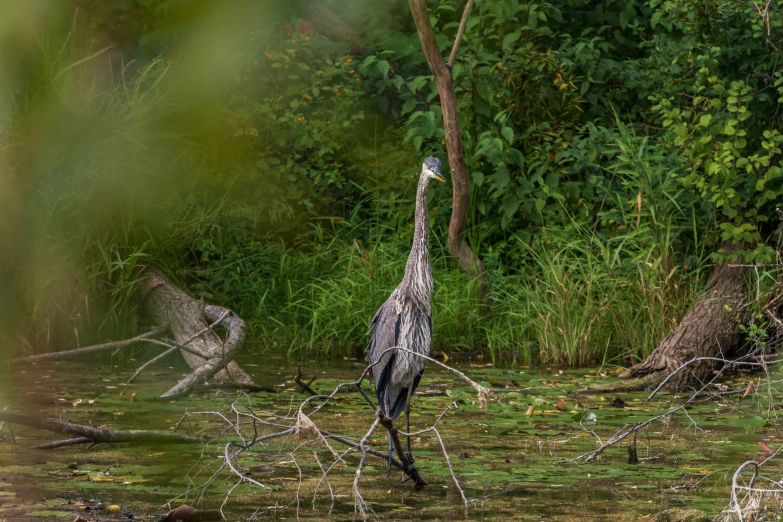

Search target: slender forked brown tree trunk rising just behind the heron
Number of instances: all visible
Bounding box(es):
[408,0,491,303]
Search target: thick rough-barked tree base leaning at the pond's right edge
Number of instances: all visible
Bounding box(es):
[620,243,748,390]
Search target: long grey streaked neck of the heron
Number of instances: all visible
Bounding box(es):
[404,176,432,301]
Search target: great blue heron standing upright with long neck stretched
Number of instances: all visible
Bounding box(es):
[367,157,445,466]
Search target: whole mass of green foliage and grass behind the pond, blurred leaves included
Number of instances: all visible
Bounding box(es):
[0,0,783,365]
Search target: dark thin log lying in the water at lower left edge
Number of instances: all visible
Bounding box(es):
[0,411,201,444]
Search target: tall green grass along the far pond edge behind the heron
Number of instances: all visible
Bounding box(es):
[150,206,701,366]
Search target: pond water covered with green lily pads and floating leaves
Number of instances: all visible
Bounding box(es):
[0,356,783,521]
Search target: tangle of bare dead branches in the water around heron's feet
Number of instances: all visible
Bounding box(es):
[164,347,496,518]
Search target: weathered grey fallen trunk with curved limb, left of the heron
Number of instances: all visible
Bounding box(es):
[139,267,253,385]
